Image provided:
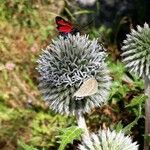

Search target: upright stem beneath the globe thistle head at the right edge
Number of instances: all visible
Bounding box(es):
[144,77,150,150]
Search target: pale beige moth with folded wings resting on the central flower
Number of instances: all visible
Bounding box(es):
[73,78,98,97]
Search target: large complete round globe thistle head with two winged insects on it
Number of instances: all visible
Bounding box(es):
[37,34,111,115]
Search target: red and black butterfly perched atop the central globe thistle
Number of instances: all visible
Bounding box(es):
[55,16,79,36]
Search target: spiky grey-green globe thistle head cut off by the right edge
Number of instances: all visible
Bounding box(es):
[122,23,150,79]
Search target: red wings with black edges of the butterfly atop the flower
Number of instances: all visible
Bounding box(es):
[55,16,74,34]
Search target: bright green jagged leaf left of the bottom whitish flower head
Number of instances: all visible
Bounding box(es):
[58,126,83,150]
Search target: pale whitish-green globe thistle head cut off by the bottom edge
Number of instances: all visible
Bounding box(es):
[78,130,138,150]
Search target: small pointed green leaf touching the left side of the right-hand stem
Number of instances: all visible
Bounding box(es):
[126,94,147,107]
